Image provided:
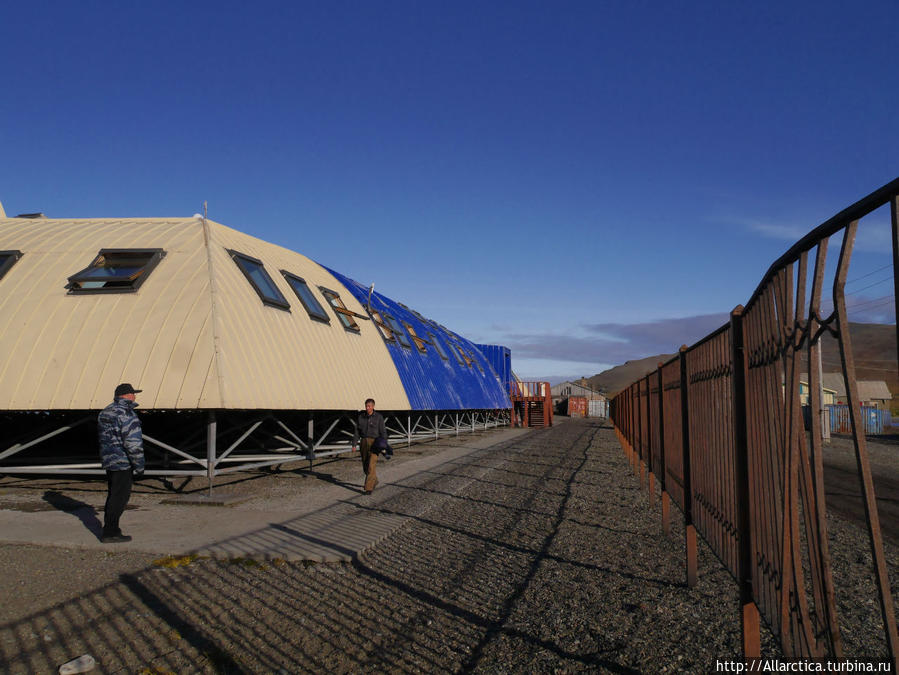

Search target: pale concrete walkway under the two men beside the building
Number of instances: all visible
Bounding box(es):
[0,429,530,562]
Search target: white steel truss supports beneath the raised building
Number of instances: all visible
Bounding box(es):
[0,409,510,489]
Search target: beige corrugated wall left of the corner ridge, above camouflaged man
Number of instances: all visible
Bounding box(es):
[0,218,218,410]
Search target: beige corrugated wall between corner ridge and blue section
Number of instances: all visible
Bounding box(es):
[200,222,409,410]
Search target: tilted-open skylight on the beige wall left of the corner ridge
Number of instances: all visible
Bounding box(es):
[66,248,165,293]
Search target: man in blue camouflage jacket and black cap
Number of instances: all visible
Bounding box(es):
[97,382,144,544]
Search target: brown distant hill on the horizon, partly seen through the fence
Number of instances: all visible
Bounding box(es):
[587,323,899,398]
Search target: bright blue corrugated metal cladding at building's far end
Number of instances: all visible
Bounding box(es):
[328,269,512,410]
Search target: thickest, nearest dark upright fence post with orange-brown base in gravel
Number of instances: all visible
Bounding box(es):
[730,305,762,659]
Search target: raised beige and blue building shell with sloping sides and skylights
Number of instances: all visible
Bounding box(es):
[0,216,511,478]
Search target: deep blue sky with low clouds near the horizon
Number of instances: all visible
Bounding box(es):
[0,1,899,381]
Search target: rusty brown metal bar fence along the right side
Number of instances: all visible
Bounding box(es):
[611,179,899,669]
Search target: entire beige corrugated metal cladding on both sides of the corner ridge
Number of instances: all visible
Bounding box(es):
[0,218,409,410]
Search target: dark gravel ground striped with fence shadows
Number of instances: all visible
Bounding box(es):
[0,420,899,673]
